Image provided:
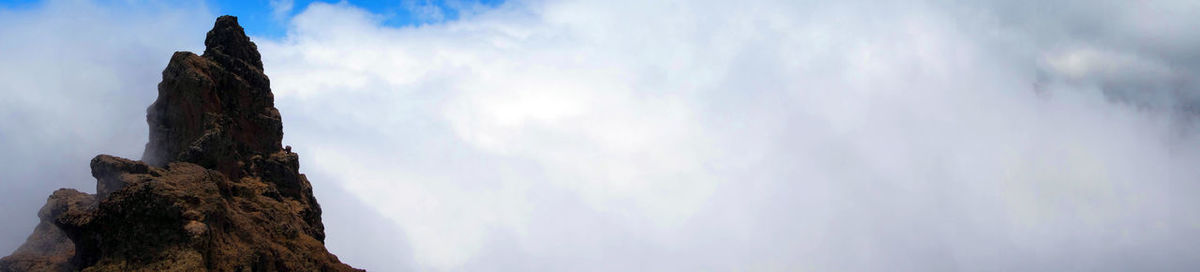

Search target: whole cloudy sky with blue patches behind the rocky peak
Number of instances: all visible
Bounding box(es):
[0,0,1200,271]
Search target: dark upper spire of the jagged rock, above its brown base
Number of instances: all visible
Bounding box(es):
[142,16,283,179]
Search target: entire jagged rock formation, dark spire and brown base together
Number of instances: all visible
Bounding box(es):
[0,16,358,272]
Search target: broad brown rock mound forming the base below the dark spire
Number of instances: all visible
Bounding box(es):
[59,162,353,271]
